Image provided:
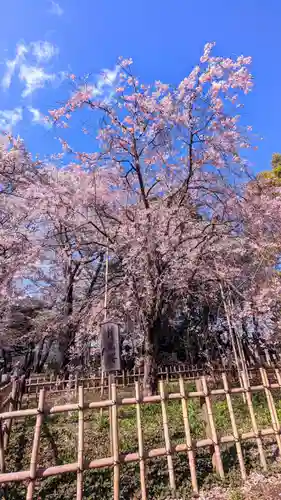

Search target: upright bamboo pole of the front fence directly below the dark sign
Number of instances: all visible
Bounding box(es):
[111,384,120,500]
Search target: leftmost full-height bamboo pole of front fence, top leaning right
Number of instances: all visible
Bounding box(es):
[26,389,45,500]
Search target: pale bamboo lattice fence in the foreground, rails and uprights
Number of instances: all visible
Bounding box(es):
[0,368,281,500]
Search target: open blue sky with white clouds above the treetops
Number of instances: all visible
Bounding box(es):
[0,0,281,170]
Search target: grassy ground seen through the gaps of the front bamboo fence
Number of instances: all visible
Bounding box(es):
[3,378,281,500]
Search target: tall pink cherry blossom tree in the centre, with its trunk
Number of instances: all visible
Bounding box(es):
[46,44,252,392]
